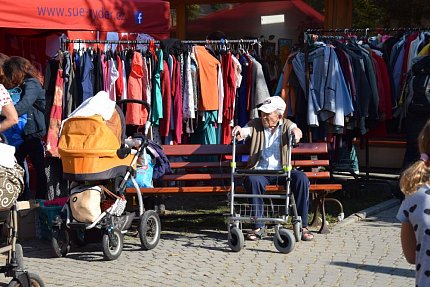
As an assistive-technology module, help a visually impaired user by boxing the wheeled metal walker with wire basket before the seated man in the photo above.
[228,135,302,253]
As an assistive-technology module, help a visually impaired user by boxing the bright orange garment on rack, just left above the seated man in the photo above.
[194,46,221,111]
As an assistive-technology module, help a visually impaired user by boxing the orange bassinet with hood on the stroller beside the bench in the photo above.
[58,113,133,181]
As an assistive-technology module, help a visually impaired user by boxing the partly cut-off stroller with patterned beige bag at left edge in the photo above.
[0,134,45,286]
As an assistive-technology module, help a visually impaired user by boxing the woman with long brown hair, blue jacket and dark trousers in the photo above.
[3,56,47,200]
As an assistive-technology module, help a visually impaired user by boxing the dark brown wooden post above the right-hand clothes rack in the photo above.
[324,0,352,29]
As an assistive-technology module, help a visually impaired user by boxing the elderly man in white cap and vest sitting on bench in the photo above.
[232,96,314,241]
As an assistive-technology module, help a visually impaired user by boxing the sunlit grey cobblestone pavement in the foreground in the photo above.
[0,202,415,287]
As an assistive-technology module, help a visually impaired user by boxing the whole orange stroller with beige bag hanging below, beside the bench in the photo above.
[51,98,161,260]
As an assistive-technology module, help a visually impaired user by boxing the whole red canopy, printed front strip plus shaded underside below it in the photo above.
[0,0,170,68]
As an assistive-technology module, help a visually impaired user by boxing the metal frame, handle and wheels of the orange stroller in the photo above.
[51,99,161,260]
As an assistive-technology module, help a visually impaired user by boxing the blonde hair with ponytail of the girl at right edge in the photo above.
[400,120,430,195]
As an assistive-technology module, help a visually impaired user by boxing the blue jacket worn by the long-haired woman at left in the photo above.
[15,78,46,138]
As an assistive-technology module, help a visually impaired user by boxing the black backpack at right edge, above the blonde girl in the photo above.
[408,56,430,115]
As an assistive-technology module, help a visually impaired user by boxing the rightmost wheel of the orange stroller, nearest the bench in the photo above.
[139,210,161,250]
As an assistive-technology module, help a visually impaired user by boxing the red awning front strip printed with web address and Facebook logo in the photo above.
[0,0,170,38]
